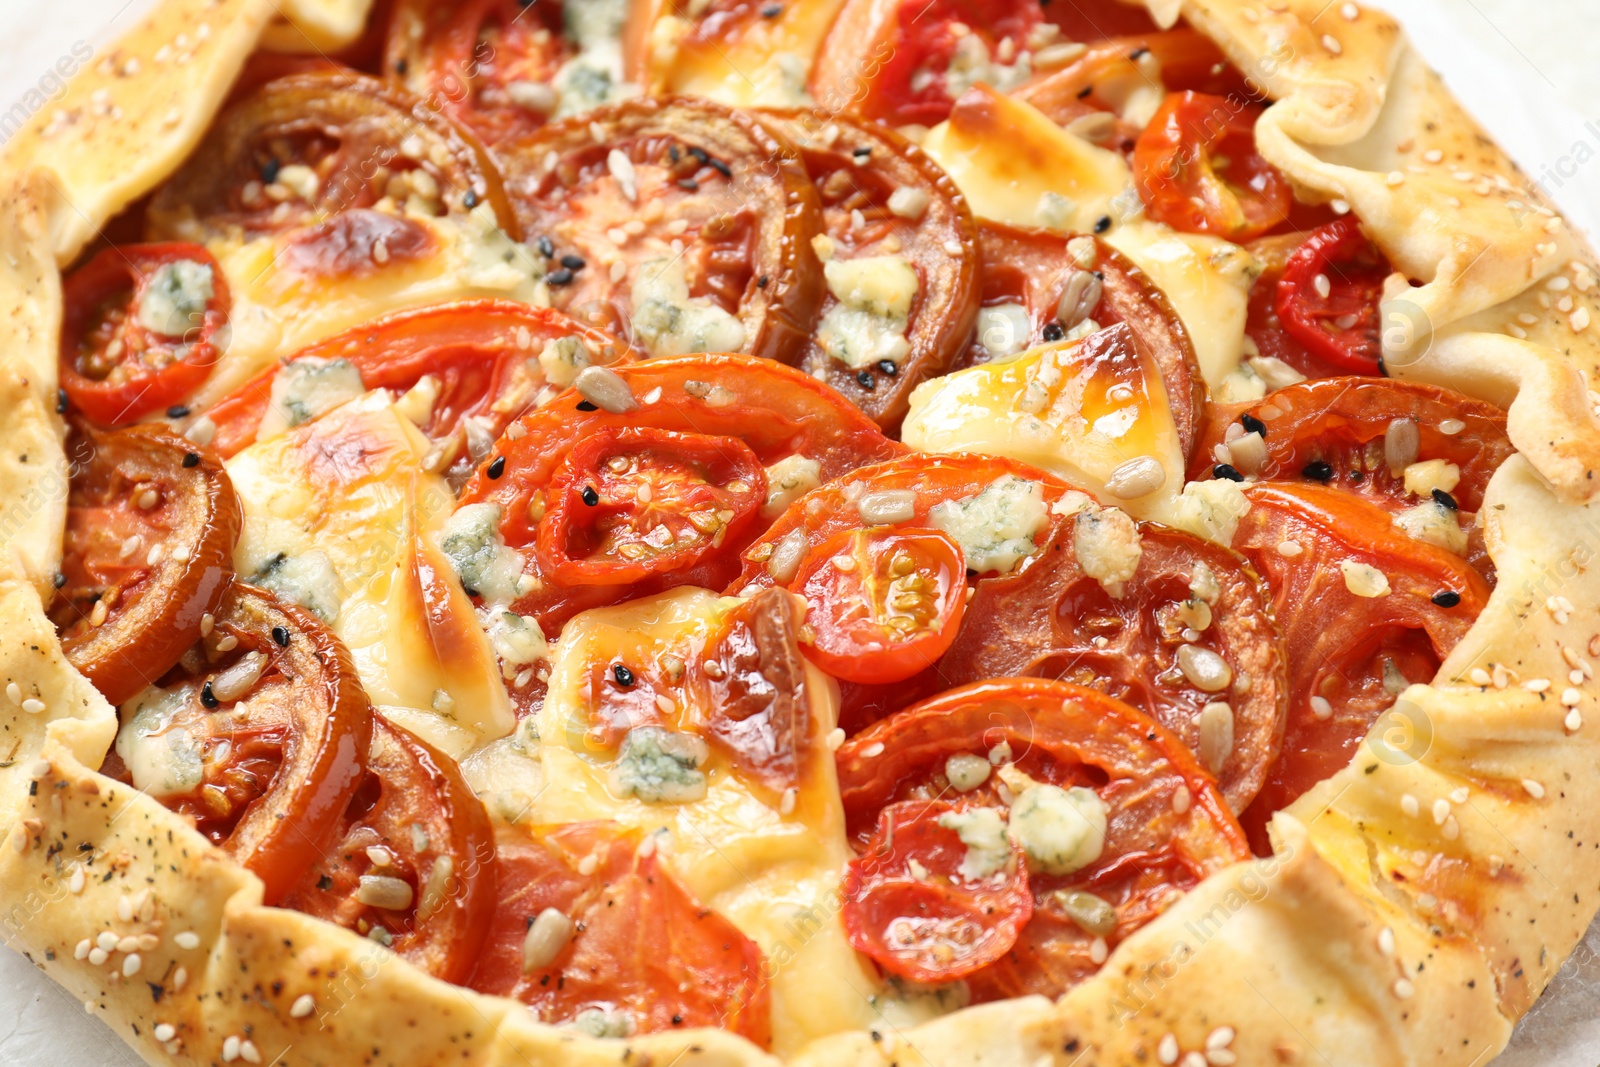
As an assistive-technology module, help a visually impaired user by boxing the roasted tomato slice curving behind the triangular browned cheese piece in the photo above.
[960,222,1206,456]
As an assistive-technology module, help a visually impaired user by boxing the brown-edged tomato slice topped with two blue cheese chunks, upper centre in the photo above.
[766,110,978,432]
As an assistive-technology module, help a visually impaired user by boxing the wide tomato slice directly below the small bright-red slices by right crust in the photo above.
[1189,378,1515,512]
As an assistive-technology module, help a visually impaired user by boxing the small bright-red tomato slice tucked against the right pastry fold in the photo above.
[1277,214,1390,374]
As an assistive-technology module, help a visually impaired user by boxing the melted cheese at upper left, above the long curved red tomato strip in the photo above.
[190,205,549,410]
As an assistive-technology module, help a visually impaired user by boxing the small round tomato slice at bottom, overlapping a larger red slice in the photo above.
[843,798,1034,982]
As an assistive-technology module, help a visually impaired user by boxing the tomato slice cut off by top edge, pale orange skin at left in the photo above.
[810,0,1061,126]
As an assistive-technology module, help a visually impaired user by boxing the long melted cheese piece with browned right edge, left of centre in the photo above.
[227,390,515,755]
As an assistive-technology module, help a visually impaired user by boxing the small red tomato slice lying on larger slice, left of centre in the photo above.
[534,427,766,585]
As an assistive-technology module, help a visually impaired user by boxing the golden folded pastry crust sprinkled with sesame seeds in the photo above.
[0,0,1600,1067]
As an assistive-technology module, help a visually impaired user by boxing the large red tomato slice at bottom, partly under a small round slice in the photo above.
[837,678,1248,1001]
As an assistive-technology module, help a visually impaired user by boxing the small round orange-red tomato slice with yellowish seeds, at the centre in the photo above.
[794,526,966,681]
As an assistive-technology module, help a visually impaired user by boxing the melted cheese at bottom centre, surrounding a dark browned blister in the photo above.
[512,589,882,1054]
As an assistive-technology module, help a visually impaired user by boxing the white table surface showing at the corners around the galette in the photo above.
[0,0,1600,1067]
